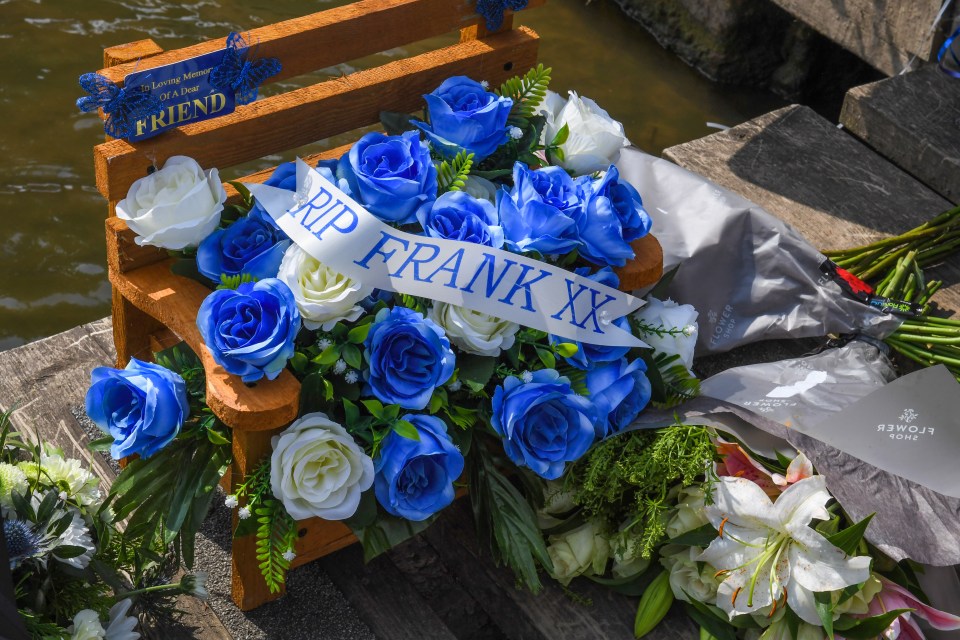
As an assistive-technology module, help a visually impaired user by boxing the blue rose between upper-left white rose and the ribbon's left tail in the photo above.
[197,209,290,282]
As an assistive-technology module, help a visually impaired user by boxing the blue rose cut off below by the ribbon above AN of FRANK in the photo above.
[417,191,503,249]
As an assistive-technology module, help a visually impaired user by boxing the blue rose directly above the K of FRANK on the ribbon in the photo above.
[497,162,583,255]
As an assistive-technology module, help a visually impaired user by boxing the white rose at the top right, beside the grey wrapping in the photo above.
[540,91,630,175]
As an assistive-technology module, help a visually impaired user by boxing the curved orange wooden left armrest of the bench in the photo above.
[107,252,300,431]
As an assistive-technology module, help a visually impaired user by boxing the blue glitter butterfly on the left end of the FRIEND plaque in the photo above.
[77,73,163,138]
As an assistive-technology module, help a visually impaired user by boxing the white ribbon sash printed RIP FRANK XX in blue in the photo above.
[251,159,647,347]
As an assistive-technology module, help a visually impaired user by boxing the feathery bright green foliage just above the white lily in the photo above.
[567,423,716,558]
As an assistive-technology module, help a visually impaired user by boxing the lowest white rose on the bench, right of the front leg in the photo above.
[270,413,373,520]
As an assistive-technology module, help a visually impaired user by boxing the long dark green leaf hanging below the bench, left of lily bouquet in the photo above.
[468,444,553,593]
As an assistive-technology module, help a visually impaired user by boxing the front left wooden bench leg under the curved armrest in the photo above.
[229,429,285,611]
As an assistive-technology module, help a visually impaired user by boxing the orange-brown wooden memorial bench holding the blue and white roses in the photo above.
[94,0,662,610]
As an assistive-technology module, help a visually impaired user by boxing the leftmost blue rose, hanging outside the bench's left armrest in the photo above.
[86,358,190,460]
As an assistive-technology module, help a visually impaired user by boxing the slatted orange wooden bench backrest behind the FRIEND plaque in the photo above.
[94,0,545,203]
